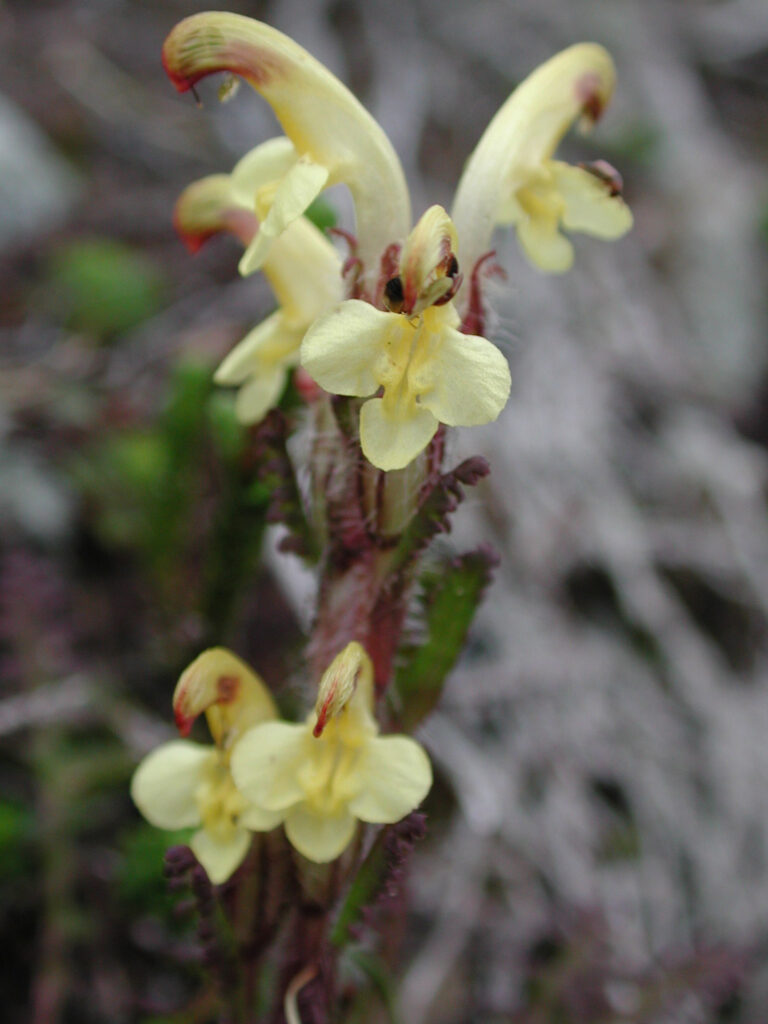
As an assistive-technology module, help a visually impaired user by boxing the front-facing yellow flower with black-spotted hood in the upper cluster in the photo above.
[301,206,510,470]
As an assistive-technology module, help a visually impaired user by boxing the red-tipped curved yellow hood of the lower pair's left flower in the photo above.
[173,647,276,749]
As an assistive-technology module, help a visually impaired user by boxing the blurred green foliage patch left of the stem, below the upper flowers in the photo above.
[69,360,271,645]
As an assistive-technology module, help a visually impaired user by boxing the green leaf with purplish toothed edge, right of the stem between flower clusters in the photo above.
[394,547,498,731]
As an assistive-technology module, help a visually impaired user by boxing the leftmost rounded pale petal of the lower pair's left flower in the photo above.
[131,739,211,829]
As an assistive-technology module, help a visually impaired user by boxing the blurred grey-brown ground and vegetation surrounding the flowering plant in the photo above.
[0,0,768,1024]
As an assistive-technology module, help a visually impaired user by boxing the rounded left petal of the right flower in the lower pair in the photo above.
[230,722,309,811]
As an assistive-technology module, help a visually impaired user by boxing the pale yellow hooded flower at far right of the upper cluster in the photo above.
[452,43,632,273]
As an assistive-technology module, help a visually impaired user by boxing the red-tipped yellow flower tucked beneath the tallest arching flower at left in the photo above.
[174,138,342,424]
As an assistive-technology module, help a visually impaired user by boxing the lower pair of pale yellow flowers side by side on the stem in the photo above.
[131,642,432,884]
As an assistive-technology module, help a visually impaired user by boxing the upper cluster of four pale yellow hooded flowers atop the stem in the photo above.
[163,12,632,470]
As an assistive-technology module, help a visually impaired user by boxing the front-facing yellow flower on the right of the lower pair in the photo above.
[231,642,432,863]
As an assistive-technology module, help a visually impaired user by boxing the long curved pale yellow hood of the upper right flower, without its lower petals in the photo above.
[452,43,615,299]
